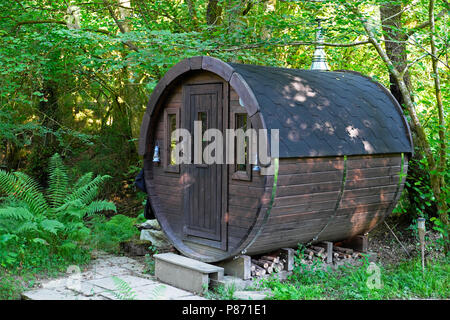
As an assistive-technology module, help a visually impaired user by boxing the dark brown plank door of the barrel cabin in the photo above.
[182,84,226,249]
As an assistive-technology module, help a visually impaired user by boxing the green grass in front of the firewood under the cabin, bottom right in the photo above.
[261,252,450,300]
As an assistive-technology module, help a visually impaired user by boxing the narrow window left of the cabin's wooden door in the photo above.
[164,108,180,173]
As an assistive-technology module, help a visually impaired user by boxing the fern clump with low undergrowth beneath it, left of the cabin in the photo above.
[0,154,116,267]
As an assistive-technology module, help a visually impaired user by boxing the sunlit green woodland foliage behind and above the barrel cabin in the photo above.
[0,0,450,230]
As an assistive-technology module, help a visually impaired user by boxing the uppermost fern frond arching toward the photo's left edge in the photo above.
[0,170,49,215]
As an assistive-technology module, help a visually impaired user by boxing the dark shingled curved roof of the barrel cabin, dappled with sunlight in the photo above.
[230,63,413,157]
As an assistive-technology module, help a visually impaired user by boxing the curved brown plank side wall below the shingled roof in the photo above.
[244,154,408,253]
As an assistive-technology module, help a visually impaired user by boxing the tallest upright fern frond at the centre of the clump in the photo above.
[48,153,69,208]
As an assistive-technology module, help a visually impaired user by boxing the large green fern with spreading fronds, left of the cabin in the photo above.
[0,154,116,251]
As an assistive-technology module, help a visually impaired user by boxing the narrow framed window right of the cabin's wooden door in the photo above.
[231,107,252,181]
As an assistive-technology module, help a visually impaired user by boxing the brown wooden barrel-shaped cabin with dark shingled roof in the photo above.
[139,56,413,262]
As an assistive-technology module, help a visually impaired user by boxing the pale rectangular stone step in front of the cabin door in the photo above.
[153,253,224,293]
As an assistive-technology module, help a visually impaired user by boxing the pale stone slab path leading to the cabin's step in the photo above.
[22,253,206,300]
